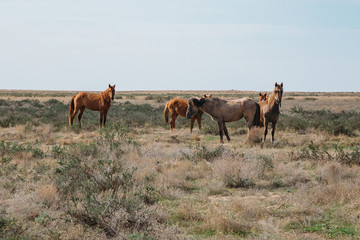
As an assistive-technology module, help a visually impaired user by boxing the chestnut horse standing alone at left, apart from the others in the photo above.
[69,84,115,128]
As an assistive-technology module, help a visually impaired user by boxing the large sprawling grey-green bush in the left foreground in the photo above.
[54,159,167,237]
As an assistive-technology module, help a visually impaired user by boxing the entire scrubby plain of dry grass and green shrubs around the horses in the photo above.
[0,91,360,239]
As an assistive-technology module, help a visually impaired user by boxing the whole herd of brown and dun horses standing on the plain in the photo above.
[69,83,283,142]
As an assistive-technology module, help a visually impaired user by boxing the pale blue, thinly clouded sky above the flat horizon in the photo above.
[0,0,360,91]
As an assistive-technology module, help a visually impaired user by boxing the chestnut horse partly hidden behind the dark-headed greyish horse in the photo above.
[164,95,212,133]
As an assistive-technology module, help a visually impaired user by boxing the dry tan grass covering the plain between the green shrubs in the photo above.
[0,91,360,239]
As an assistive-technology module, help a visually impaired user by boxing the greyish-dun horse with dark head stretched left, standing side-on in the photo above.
[186,97,260,143]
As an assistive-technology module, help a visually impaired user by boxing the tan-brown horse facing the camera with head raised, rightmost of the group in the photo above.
[259,82,283,143]
